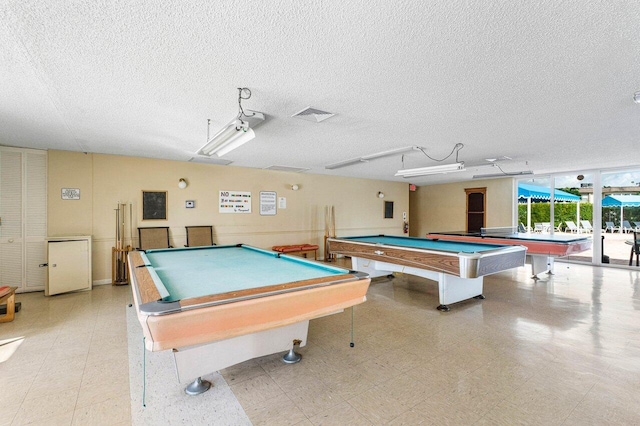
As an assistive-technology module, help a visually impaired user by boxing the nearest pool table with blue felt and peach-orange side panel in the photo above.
[129,244,370,393]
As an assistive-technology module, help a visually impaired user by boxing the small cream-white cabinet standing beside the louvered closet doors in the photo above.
[44,235,92,296]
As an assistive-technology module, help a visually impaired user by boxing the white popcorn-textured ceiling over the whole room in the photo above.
[0,0,640,185]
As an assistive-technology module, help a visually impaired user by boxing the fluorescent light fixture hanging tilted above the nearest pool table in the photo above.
[198,87,265,157]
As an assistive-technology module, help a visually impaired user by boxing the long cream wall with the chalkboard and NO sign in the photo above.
[47,150,409,283]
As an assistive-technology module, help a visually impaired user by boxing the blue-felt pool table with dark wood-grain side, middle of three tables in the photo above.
[327,235,526,311]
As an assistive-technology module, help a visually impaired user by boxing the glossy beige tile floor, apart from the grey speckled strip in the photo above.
[0,262,640,425]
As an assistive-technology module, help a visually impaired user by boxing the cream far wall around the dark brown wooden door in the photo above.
[410,178,516,237]
